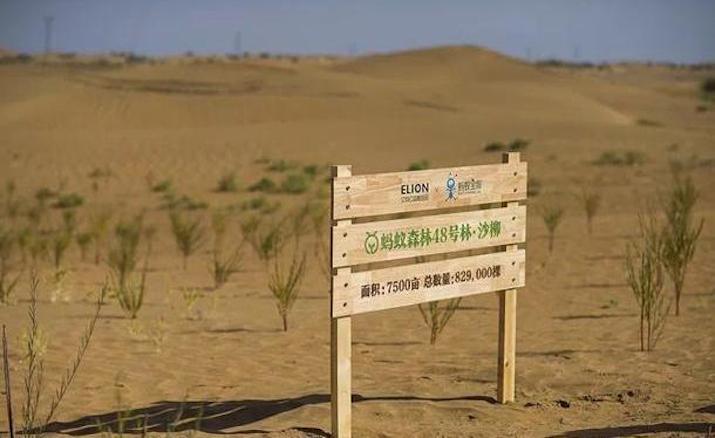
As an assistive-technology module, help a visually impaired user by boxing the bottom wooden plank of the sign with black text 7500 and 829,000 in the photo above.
[331,250,525,318]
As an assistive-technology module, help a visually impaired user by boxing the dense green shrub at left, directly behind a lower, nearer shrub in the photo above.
[107,216,143,288]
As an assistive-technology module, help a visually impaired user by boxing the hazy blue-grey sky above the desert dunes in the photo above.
[0,0,715,63]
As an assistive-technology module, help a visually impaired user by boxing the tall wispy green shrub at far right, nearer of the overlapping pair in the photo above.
[625,214,670,351]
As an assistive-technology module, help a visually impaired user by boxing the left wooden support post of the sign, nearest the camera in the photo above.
[330,166,352,438]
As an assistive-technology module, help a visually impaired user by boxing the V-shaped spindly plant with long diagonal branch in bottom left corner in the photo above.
[22,272,107,437]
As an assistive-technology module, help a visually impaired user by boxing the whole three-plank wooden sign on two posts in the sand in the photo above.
[331,153,527,437]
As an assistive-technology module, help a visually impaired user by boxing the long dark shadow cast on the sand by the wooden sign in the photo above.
[39,394,496,437]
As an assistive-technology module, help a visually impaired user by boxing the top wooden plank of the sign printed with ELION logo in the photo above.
[333,162,527,219]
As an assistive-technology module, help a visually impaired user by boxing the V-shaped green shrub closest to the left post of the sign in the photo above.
[268,247,306,331]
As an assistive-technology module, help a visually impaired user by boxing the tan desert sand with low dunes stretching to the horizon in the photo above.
[0,47,715,437]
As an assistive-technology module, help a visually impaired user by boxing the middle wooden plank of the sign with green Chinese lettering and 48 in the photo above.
[332,204,526,267]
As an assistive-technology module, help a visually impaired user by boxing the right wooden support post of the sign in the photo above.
[497,152,519,403]
